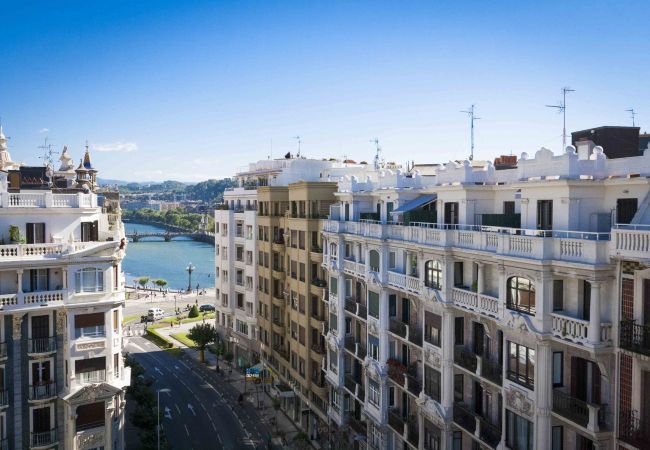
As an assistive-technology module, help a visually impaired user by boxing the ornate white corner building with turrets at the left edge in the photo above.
[0,129,130,450]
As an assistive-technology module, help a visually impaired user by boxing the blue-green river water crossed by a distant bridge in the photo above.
[123,223,214,289]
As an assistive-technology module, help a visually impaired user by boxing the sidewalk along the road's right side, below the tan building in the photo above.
[156,321,300,448]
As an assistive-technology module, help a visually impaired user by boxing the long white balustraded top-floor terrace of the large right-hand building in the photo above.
[323,220,612,264]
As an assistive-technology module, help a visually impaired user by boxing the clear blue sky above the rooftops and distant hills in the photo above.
[0,0,650,181]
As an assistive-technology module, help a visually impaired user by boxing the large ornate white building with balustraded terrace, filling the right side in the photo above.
[323,141,650,450]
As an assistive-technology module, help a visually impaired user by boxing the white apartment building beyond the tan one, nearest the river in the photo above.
[215,157,359,367]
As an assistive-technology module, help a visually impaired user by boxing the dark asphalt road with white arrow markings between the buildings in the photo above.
[126,337,273,450]
